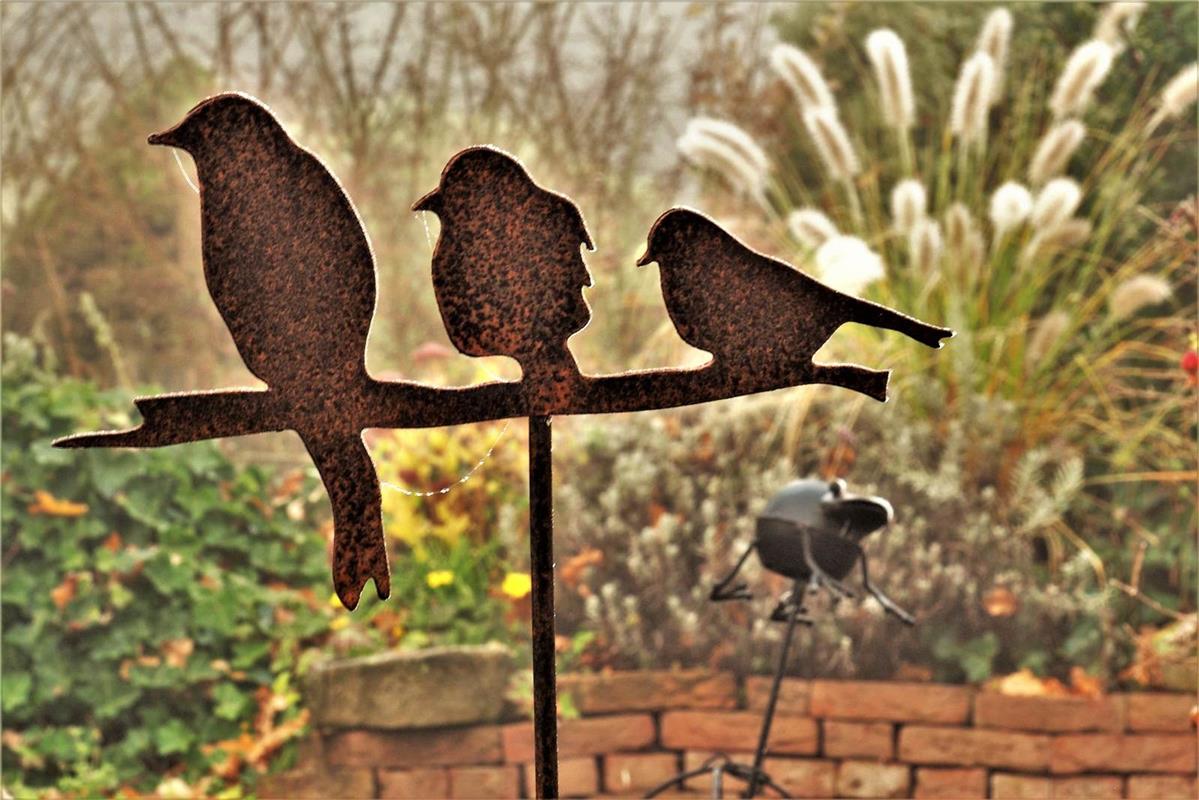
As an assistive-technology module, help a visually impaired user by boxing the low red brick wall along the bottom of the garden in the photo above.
[261,672,1197,800]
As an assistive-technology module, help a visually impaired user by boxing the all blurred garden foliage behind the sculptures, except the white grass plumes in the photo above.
[0,2,1199,798]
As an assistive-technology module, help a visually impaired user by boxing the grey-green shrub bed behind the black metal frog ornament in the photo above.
[556,384,1179,681]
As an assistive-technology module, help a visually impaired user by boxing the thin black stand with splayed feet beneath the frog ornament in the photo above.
[645,578,819,798]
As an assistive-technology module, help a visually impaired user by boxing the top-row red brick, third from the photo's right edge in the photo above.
[811,680,972,723]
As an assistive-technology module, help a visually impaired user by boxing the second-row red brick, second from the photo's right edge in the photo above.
[899,726,1049,770]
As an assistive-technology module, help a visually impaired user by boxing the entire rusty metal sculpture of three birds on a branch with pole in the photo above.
[55,94,952,798]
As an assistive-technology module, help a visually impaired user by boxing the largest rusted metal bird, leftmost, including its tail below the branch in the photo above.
[149,94,390,608]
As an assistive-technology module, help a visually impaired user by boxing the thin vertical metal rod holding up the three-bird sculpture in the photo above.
[529,416,558,800]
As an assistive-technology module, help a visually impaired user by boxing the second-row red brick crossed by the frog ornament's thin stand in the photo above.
[662,711,820,756]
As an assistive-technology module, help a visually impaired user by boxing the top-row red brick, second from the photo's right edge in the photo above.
[974,692,1123,733]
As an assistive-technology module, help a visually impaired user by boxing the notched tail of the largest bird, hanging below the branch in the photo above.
[300,431,391,610]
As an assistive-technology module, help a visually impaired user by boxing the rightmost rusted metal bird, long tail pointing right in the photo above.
[637,209,953,393]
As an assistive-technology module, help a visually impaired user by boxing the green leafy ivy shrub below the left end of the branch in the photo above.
[0,338,331,796]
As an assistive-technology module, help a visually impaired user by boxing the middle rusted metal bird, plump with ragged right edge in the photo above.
[412,148,594,391]
